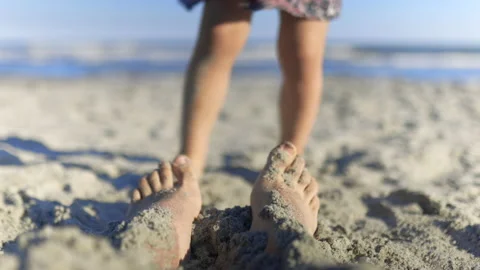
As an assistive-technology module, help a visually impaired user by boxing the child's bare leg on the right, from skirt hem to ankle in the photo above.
[278,12,328,154]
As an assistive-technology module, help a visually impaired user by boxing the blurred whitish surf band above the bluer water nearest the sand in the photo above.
[0,42,480,69]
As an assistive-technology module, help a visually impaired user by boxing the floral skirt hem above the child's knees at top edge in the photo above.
[179,0,342,20]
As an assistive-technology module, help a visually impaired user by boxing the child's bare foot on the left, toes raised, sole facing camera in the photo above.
[127,155,202,267]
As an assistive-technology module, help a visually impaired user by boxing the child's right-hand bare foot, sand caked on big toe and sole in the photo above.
[250,142,320,252]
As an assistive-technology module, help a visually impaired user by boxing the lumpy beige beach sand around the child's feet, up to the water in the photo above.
[0,76,480,269]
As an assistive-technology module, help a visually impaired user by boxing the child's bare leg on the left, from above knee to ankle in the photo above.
[181,0,252,176]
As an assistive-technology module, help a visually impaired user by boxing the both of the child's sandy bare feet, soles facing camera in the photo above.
[128,142,319,266]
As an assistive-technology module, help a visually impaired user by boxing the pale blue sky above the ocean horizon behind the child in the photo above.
[0,0,480,44]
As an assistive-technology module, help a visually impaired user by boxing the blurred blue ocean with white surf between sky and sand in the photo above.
[0,41,480,81]
